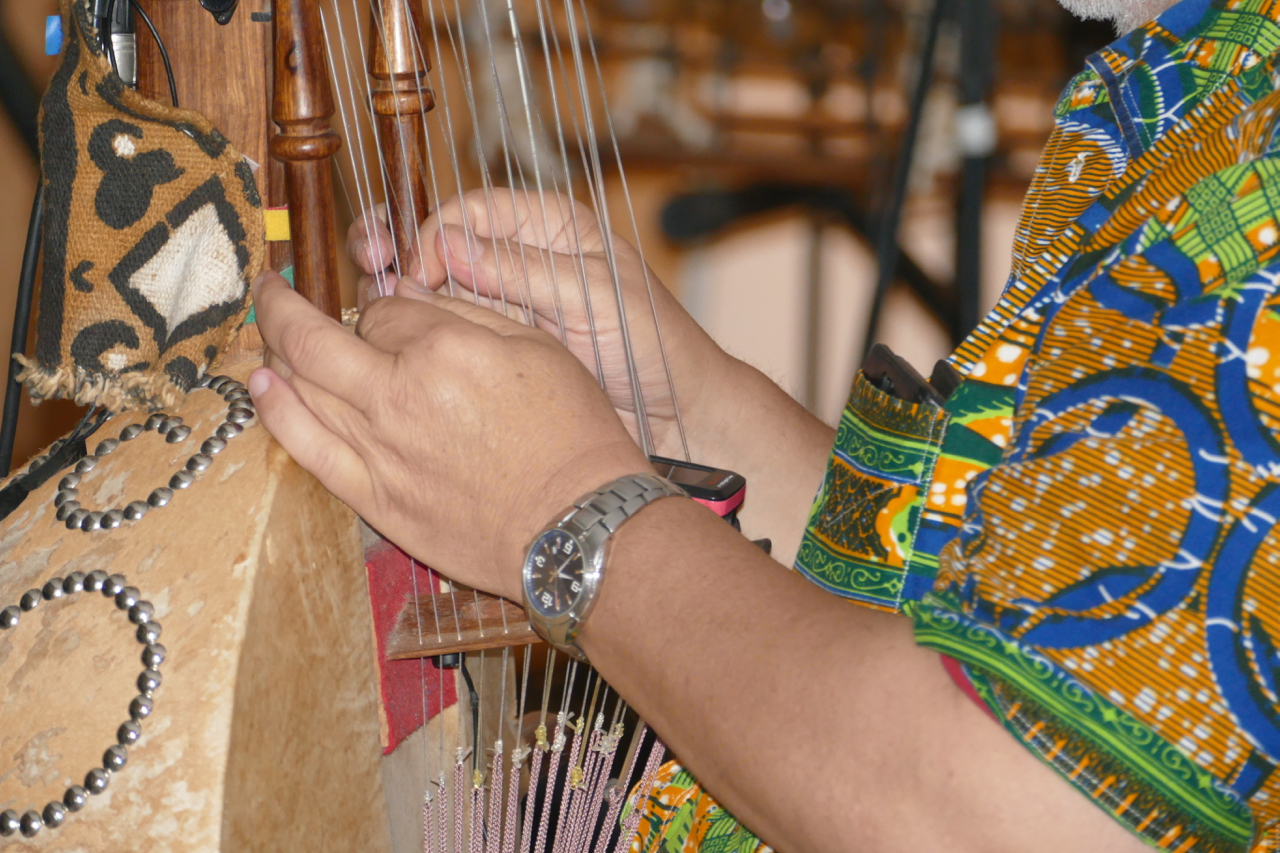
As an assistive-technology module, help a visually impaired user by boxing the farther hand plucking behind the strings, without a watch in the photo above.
[348,188,732,457]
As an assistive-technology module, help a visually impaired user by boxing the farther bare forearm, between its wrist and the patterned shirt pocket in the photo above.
[686,356,836,566]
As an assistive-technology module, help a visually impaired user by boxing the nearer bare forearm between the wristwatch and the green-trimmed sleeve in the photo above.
[581,501,1139,853]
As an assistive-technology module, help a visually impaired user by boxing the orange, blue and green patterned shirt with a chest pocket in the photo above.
[634,0,1280,853]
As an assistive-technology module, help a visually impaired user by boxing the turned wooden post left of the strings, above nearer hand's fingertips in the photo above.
[271,0,342,319]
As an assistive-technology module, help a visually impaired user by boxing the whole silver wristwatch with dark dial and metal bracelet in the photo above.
[524,474,685,661]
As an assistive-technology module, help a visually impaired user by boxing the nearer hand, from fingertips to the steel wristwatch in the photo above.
[248,267,652,601]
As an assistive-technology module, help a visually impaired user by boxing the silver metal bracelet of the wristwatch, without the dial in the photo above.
[524,474,687,661]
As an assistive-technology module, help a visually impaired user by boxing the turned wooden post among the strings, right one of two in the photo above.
[369,0,435,273]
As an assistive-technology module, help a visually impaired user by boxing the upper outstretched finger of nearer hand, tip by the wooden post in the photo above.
[253,272,385,409]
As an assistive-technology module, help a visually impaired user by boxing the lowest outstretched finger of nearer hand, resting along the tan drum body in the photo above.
[248,368,370,506]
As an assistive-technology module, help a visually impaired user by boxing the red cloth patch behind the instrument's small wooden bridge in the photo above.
[365,539,458,756]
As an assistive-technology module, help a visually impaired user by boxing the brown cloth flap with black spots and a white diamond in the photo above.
[19,0,266,411]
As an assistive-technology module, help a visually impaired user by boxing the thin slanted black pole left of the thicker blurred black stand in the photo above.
[863,0,951,356]
